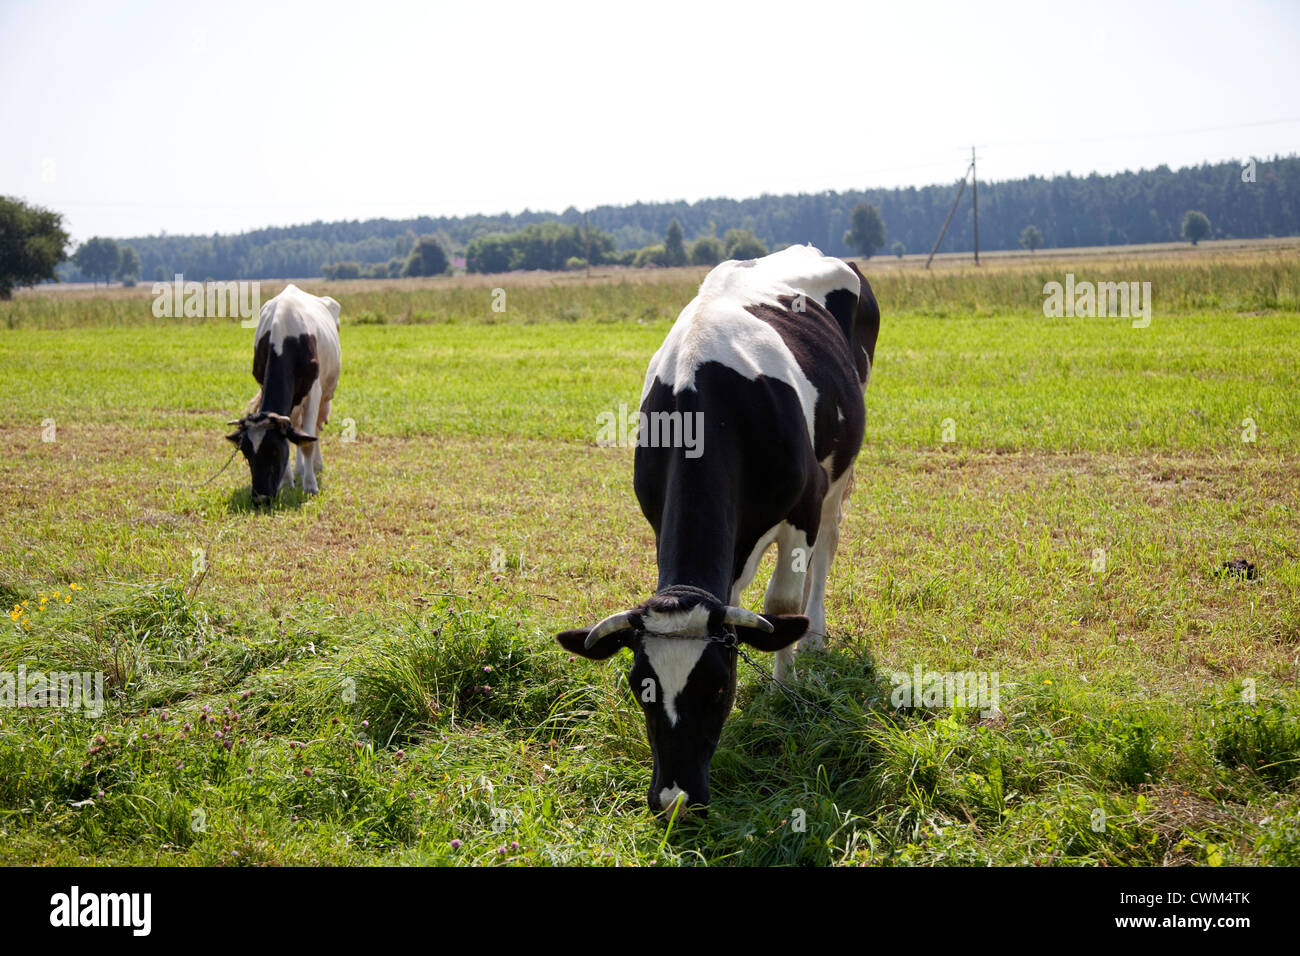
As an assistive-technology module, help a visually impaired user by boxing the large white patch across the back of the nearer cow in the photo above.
[641,246,859,440]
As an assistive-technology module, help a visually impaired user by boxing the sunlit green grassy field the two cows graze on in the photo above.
[0,243,1300,865]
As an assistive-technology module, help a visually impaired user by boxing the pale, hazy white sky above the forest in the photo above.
[0,0,1300,241]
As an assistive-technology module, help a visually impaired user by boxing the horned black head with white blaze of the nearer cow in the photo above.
[556,585,809,813]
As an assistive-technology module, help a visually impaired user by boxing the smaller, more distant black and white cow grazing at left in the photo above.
[226,284,342,505]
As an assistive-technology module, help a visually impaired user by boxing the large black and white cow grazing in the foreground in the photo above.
[556,246,880,810]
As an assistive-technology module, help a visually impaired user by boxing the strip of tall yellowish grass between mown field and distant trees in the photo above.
[0,251,1300,329]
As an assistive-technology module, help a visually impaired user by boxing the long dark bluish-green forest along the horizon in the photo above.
[60,156,1300,281]
